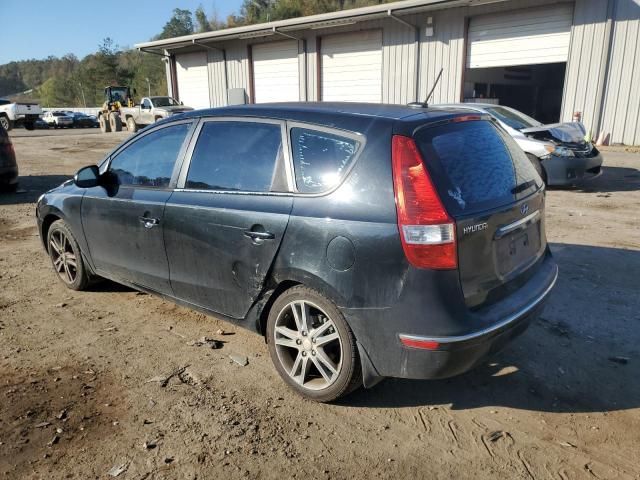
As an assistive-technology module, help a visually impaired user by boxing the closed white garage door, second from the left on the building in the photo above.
[251,40,300,103]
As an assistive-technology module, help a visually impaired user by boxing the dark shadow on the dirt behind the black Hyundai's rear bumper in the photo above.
[340,244,640,413]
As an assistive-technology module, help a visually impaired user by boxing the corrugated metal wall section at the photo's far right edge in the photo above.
[601,0,640,145]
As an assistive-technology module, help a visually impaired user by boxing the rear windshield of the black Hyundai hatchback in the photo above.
[415,120,542,216]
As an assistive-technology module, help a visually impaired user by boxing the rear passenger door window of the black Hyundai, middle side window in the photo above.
[185,122,286,192]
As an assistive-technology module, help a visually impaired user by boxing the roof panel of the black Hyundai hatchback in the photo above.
[181,102,482,124]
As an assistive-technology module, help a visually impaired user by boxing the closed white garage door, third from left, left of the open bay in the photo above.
[320,30,382,103]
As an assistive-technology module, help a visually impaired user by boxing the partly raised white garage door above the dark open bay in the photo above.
[467,3,573,68]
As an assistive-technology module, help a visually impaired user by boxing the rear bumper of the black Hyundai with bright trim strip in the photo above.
[342,254,558,386]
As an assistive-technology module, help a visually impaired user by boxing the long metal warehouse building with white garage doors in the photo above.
[136,0,640,145]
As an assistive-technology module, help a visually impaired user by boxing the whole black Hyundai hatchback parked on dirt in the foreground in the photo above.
[37,103,557,401]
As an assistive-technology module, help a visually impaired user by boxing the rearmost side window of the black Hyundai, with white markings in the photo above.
[291,128,360,193]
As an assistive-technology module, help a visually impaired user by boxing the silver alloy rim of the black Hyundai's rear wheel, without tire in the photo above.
[273,300,343,390]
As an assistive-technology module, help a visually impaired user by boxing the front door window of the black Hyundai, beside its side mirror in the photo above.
[109,123,191,188]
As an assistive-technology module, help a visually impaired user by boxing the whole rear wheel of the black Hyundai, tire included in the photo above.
[267,286,362,402]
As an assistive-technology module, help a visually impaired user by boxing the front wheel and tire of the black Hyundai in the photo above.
[47,220,91,290]
